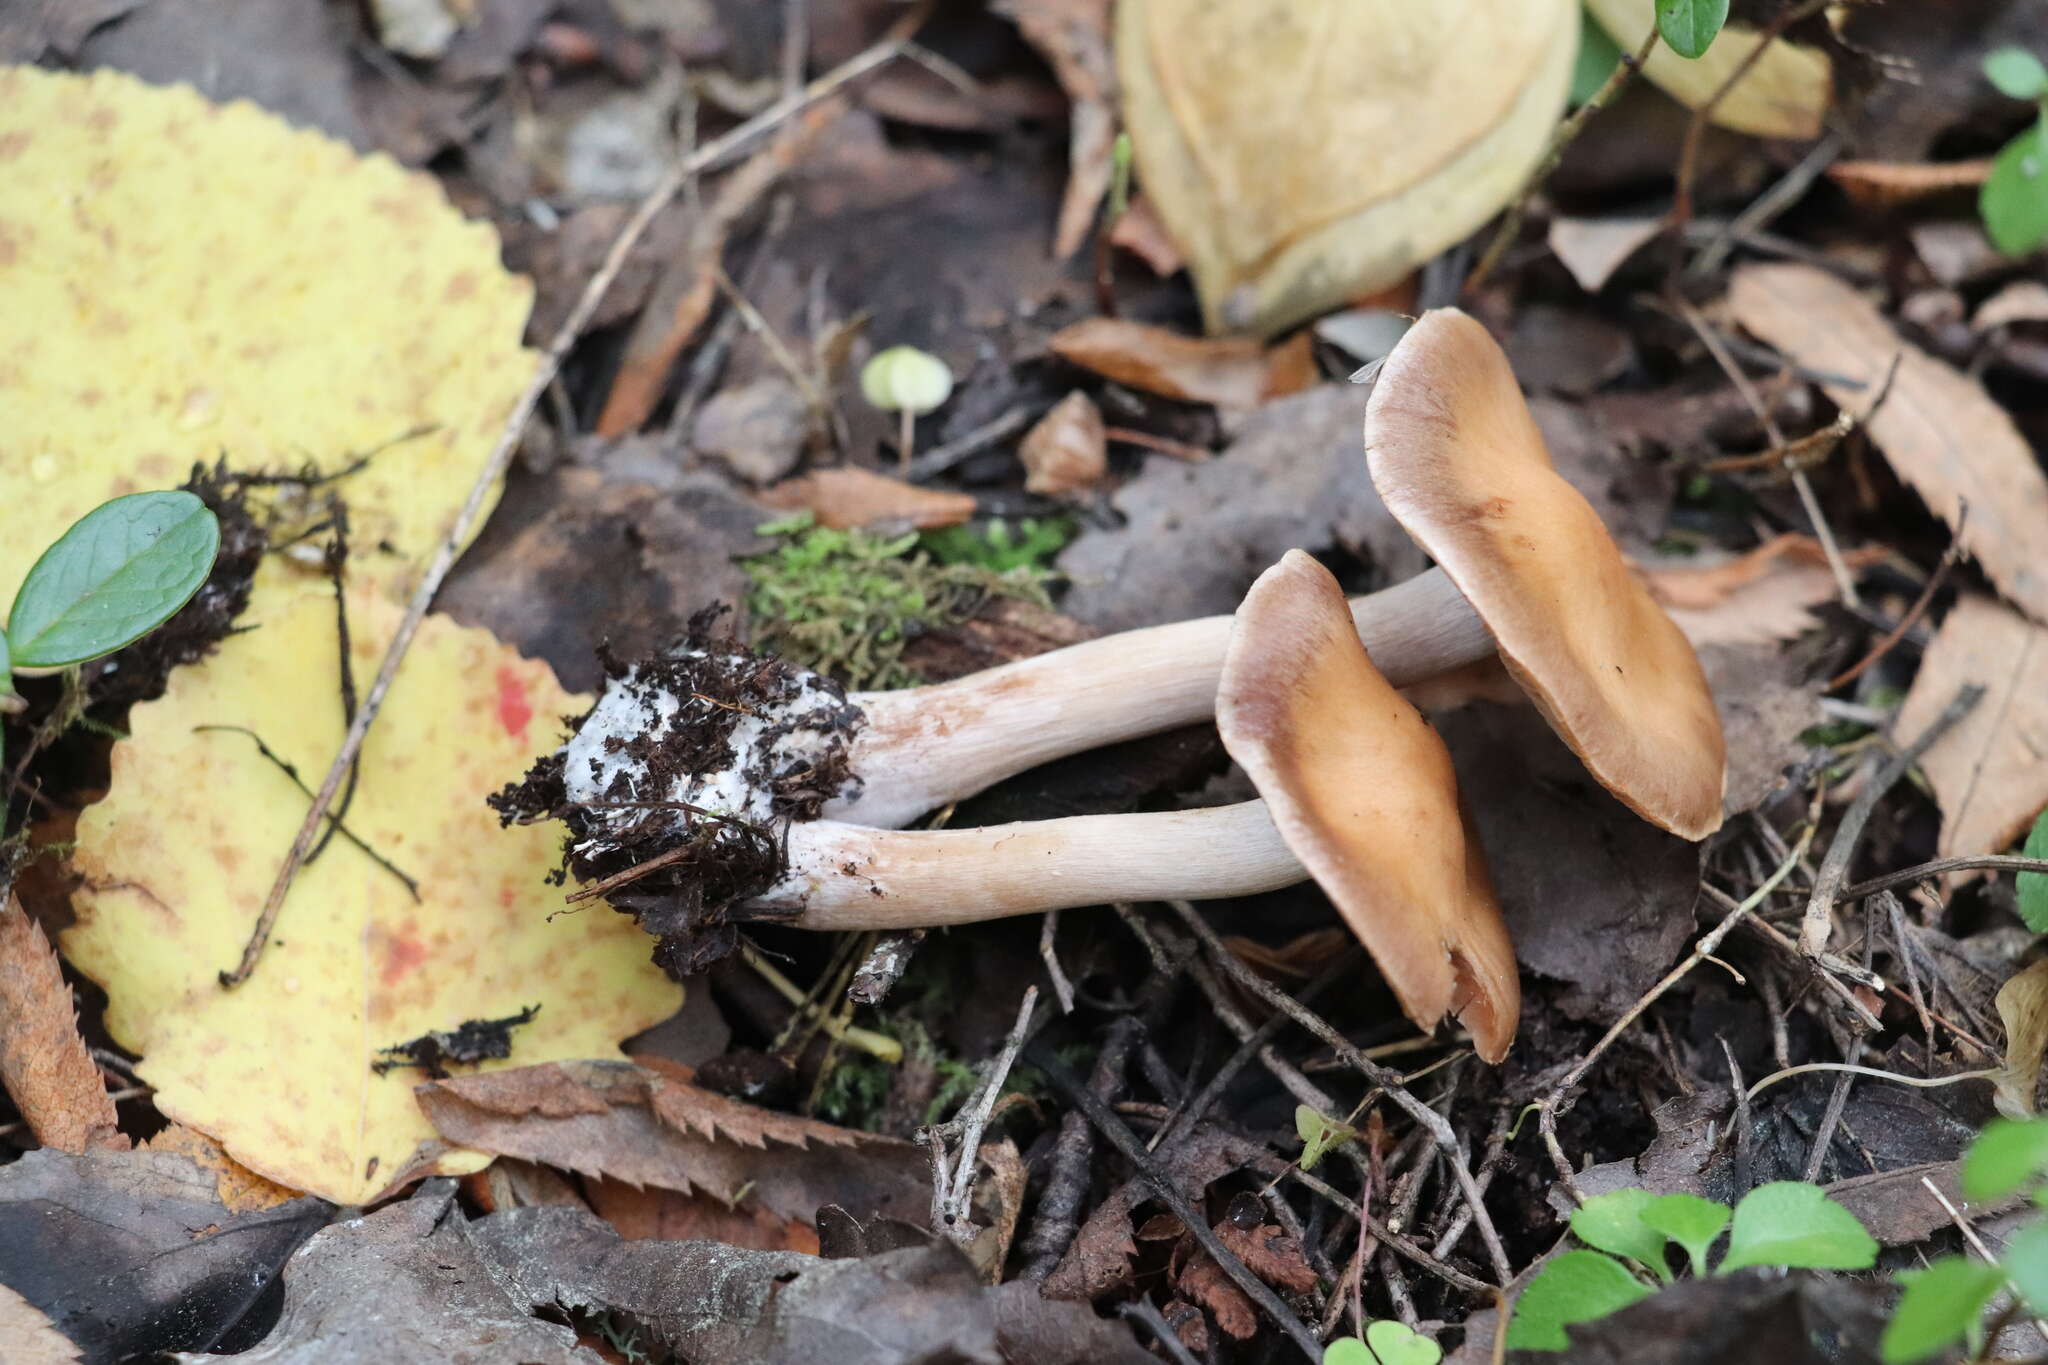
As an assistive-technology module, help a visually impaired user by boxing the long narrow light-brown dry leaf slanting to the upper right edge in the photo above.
[1729,264,2048,620]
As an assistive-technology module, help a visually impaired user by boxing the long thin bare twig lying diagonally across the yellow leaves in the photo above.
[221,34,924,988]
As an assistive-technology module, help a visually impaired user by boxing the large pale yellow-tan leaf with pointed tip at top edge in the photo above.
[1116,0,1579,336]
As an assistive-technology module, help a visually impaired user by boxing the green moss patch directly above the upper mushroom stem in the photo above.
[739,514,1065,688]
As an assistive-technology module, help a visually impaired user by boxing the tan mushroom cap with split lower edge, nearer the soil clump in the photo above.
[1217,551,1522,1062]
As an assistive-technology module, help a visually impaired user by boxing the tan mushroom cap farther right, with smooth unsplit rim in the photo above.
[1366,309,1726,839]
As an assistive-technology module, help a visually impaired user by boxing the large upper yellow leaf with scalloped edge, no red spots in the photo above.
[0,68,532,606]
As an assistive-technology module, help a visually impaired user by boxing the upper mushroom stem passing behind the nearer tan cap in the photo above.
[825,569,1493,826]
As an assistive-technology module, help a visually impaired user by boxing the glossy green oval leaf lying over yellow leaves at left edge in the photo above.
[8,491,221,669]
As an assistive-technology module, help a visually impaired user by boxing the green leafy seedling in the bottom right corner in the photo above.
[1878,1113,2048,1365]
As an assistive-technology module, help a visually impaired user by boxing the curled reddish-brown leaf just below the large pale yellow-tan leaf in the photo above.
[1047,317,1315,407]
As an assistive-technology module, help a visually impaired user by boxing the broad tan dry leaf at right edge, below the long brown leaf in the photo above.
[1896,593,2048,857]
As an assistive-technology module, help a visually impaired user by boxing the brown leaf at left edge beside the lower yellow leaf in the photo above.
[0,894,129,1152]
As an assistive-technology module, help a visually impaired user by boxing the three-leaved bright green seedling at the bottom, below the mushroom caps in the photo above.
[1507,1181,1878,1351]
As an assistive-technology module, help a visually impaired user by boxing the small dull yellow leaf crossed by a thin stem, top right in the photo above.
[1585,0,1833,137]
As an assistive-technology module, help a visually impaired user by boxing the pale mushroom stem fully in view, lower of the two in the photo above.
[754,800,1309,929]
